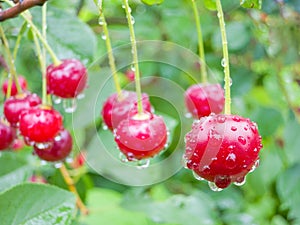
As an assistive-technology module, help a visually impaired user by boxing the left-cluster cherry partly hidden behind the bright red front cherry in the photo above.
[4,93,42,127]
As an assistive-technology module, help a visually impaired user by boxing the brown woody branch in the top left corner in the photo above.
[0,0,47,22]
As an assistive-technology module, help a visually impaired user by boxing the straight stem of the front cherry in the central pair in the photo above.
[123,0,143,115]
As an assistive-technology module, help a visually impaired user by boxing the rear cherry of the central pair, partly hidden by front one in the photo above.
[102,90,151,130]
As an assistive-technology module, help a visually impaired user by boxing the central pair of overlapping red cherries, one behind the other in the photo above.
[101,90,168,164]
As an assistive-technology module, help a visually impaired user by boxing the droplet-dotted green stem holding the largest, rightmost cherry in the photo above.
[216,0,231,115]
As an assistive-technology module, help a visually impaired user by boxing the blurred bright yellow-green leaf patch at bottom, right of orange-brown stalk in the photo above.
[79,188,149,225]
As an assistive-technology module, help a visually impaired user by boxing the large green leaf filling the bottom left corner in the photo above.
[0,184,75,225]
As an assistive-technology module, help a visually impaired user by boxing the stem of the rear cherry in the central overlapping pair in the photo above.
[94,0,122,99]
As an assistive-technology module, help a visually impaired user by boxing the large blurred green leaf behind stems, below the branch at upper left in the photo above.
[32,7,96,64]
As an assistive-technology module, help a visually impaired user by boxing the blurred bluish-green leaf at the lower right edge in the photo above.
[276,164,300,224]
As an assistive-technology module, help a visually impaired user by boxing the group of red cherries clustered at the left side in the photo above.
[0,59,87,162]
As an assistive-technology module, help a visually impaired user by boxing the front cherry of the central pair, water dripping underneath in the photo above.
[115,113,168,161]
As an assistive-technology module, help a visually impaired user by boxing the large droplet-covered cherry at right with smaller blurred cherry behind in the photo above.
[183,84,262,191]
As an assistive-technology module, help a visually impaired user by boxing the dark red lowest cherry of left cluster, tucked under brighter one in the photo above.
[34,129,73,162]
